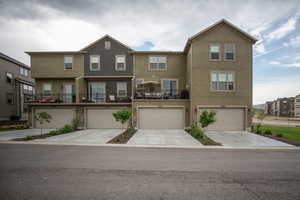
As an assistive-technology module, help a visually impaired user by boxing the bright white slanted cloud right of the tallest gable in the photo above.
[267,17,297,41]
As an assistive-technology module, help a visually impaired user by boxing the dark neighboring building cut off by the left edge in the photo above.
[0,52,34,120]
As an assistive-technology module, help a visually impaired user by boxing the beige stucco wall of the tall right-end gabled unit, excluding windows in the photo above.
[188,24,253,127]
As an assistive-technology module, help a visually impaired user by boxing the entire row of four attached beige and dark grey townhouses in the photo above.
[28,20,256,130]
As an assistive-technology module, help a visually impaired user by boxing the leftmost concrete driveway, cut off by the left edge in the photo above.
[0,129,53,141]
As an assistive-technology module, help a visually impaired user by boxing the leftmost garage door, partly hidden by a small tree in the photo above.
[35,108,76,128]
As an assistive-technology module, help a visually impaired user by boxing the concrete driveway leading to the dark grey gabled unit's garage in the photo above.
[34,129,122,144]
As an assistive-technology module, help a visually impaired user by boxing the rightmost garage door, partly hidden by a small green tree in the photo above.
[198,109,245,131]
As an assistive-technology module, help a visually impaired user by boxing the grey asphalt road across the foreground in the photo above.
[0,144,300,200]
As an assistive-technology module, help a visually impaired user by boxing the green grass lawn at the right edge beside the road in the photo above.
[261,125,300,141]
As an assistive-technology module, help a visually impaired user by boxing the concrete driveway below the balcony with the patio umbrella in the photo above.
[127,129,202,146]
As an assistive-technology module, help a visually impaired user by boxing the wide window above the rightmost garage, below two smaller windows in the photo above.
[211,72,234,91]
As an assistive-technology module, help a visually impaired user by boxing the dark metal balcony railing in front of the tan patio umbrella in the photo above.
[134,88,189,99]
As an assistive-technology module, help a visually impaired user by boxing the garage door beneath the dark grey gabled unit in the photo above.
[87,109,122,128]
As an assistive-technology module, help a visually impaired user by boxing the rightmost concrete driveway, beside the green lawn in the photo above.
[205,131,292,147]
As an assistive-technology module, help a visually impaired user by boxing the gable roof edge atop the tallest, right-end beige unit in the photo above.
[183,19,257,52]
